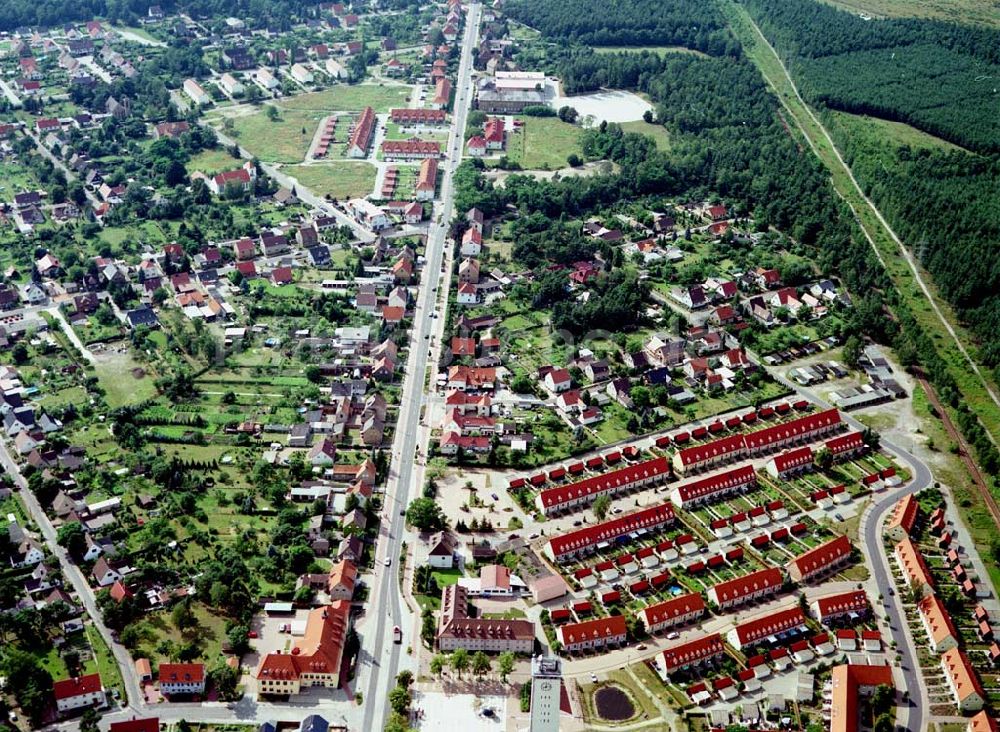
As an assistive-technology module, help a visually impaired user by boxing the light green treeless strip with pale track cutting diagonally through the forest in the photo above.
[720,0,1000,443]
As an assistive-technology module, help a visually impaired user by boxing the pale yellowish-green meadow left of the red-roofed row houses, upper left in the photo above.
[210,108,325,163]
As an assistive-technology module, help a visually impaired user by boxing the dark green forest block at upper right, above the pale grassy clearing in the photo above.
[746,0,1000,152]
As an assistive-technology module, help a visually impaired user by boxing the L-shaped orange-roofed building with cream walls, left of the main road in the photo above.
[256,600,351,697]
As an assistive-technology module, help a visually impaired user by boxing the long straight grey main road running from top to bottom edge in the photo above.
[358,3,482,730]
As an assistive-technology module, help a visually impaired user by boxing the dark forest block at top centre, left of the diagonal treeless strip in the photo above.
[504,0,739,56]
